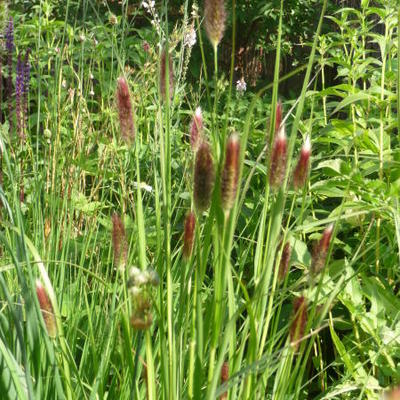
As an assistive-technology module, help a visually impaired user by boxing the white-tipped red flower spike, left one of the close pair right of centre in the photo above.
[269,125,287,188]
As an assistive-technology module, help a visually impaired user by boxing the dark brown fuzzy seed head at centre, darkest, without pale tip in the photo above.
[193,142,215,213]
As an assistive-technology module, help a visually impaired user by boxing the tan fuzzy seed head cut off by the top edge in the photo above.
[204,0,226,48]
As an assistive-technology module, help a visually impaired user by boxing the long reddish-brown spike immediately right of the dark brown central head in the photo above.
[221,133,240,212]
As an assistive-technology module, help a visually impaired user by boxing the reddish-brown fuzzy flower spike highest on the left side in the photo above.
[117,77,135,144]
